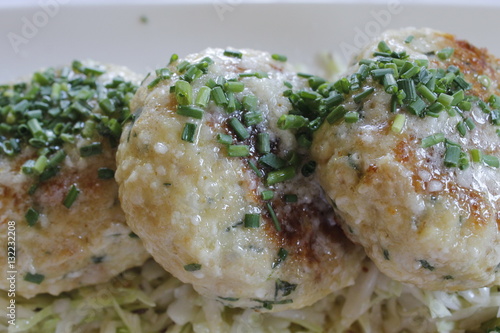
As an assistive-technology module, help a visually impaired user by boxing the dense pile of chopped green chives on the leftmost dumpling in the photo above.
[0,61,137,188]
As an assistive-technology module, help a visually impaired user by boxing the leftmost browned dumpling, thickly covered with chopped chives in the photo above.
[0,62,149,297]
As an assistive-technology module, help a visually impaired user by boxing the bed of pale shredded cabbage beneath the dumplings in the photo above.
[0,260,500,333]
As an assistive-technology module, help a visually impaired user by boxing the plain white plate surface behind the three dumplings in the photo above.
[0,0,500,83]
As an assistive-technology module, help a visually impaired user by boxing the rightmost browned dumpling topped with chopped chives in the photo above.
[312,29,500,291]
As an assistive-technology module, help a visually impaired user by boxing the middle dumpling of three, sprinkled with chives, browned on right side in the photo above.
[117,49,364,311]
